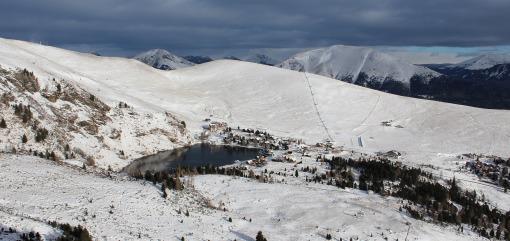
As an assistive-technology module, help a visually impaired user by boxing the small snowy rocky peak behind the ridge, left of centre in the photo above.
[134,49,195,70]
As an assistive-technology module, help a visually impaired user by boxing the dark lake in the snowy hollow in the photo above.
[124,144,260,174]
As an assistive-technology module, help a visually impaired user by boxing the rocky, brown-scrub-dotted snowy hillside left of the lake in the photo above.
[0,41,192,169]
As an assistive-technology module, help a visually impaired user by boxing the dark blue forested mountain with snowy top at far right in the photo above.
[420,54,510,110]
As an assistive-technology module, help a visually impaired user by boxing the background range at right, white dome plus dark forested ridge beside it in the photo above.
[278,45,510,109]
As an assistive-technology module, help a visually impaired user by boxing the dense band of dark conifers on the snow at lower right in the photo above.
[320,157,510,240]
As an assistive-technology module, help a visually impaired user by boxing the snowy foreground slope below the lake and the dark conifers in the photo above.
[0,155,483,241]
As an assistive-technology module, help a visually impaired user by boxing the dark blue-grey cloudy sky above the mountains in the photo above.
[0,0,510,63]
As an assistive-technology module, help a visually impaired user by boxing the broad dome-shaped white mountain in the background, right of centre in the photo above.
[278,45,438,84]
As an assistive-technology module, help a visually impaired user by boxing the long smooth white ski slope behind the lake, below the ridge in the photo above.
[0,39,510,162]
